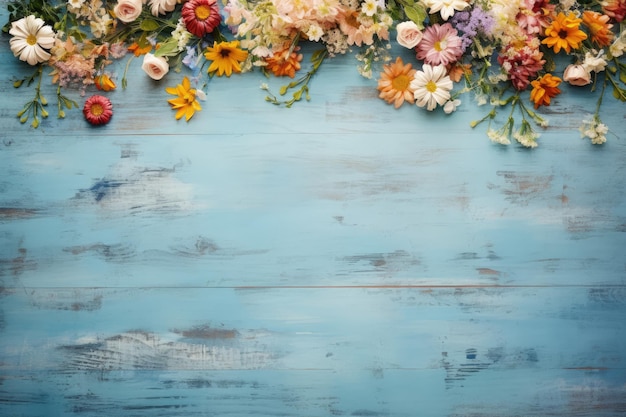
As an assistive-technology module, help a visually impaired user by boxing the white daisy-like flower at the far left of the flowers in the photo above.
[9,15,55,65]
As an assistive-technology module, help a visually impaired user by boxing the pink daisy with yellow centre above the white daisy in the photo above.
[416,23,463,66]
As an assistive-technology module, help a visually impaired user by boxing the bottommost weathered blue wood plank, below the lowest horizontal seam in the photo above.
[0,287,626,416]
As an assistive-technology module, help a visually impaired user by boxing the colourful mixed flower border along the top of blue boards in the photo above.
[3,0,626,147]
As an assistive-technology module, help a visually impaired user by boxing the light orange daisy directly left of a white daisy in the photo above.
[378,57,417,109]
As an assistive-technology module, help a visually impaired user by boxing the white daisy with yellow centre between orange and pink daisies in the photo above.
[411,64,453,111]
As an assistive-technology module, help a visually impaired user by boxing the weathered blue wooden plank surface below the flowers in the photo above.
[0,1,626,417]
